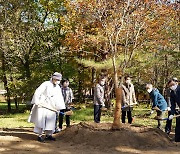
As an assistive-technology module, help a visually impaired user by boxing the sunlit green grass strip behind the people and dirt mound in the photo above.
[0,103,175,128]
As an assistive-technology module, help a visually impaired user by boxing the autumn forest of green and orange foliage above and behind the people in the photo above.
[0,0,180,112]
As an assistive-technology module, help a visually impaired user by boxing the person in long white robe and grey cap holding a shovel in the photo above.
[28,72,65,142]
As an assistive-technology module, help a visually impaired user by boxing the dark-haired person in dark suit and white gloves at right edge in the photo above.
[168,79,180,142]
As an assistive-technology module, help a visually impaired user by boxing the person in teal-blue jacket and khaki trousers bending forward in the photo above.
[146,84,167,129]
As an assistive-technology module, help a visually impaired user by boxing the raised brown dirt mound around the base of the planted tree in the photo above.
[57,123,177,153]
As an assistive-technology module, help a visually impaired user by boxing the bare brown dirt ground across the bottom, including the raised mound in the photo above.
[0,123,180,154]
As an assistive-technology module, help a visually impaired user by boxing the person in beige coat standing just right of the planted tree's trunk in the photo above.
[121,76,137,124]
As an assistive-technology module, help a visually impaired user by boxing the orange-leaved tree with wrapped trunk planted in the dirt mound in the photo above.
[63,0,179,129]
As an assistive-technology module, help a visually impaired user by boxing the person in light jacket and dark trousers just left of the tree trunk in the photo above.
[94,77,106,123]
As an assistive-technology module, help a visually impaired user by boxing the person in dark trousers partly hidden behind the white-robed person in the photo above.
[59,79,74,130]
